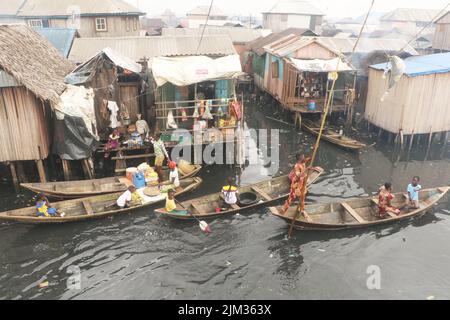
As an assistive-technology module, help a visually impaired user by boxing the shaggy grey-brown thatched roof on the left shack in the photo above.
[0,25,74,102]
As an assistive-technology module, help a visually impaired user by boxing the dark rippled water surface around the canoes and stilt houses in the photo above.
[0,106,450,299]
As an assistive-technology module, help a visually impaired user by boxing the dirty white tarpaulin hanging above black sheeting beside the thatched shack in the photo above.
[55,84,99,140]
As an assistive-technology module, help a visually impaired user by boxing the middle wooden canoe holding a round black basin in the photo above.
[155,168,324,220]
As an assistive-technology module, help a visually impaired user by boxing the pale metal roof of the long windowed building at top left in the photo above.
[18,0,144,17]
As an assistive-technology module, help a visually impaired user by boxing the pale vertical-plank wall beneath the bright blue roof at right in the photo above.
[365,69,450,134]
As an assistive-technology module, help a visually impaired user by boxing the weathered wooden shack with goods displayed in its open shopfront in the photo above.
[264,35,356,124]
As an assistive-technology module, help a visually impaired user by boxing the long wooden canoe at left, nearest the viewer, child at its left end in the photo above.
[0,177,202,224]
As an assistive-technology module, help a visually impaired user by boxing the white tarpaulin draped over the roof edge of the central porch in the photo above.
[152,55,242,87]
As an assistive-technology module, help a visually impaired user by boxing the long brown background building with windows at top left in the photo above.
[17,0,144,37]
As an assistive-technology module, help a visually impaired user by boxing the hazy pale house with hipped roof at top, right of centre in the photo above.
[263,1,325,33]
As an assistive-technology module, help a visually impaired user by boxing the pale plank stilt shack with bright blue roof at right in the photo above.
[364,53,450,143]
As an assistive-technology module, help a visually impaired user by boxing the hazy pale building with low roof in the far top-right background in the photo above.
[380,8,439,33]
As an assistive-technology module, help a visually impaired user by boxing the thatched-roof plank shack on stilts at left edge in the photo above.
[0,25,74,183]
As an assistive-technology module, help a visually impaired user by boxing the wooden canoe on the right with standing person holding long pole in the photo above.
[270,187,450,230]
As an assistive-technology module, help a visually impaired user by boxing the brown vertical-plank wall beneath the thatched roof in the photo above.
[0,87,51,162]
